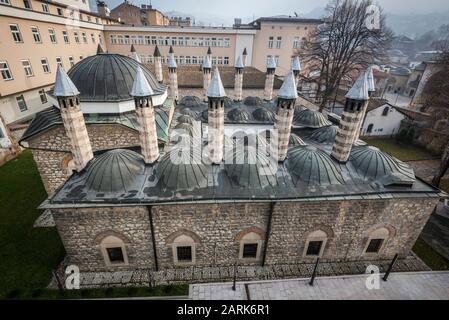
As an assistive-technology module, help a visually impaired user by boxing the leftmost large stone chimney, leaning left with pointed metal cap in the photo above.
[54,66,94,172]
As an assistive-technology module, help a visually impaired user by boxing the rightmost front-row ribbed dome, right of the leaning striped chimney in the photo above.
[349,146,415,186]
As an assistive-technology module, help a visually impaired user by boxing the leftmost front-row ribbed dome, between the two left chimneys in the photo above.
[86,149,145,193]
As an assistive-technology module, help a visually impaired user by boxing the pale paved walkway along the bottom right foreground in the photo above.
[189,272,449,300]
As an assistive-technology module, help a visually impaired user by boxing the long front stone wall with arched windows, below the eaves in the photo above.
[52,198,438,271]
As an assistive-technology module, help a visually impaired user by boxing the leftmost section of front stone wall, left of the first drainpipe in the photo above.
[52,207,154,271]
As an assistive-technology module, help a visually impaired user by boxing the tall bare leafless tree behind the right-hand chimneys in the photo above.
[305,0,392,111]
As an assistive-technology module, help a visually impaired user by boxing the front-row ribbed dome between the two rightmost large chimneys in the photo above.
[287,146,344,185]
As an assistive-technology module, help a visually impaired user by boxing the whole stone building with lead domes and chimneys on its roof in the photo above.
[21,54,441,284]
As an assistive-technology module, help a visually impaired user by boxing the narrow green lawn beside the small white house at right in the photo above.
[363,138,437,161]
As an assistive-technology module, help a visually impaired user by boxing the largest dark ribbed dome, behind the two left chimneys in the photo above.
[68,53,165,102]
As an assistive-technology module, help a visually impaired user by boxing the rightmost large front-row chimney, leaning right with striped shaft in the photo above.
[332,72,369,163]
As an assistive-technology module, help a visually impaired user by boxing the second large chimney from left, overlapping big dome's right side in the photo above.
[131,65,159,163]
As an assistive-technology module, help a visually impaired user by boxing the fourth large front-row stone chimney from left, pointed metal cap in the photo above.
[274,71,298,161]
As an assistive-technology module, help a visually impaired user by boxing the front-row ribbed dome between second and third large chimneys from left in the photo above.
[156,147,208,190]
